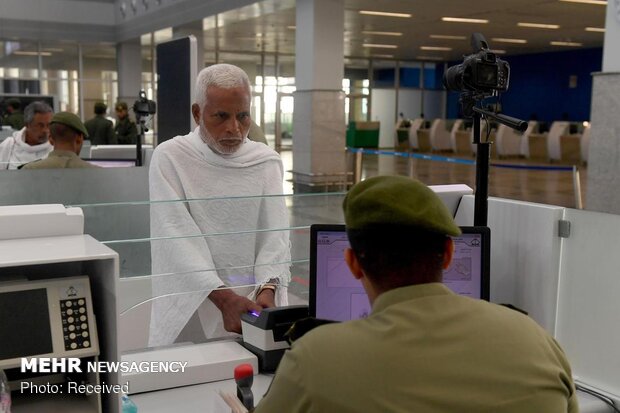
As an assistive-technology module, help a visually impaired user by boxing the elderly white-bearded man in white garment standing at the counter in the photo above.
[149,64,290,346]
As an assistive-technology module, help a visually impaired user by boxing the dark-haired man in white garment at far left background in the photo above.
[0,101,52,169]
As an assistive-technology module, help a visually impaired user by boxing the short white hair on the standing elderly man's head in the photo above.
[195,63,251,109]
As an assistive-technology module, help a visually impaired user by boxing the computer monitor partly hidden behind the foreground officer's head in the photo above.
[309,224,491,321]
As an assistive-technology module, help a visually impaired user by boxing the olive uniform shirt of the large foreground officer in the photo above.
[254,283,578,413]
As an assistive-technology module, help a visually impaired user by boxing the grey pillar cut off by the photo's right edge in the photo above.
[585,0,620,214]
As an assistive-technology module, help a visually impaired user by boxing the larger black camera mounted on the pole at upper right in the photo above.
[443,33,510,96]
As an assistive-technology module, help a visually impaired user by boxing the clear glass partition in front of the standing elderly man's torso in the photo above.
[73,192,345,350]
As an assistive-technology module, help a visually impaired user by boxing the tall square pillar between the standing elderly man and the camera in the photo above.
[293,0,347,191]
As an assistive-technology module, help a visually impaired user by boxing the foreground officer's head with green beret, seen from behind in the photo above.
[343,176,461,295]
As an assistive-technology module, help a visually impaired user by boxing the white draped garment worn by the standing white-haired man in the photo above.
[149,128,290,346]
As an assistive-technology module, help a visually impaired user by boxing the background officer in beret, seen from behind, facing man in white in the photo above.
[21,112,96,169]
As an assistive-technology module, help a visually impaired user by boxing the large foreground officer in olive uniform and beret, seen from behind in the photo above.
[255,176,578,413]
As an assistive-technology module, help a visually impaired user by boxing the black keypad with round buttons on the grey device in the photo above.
[60,298,90,350]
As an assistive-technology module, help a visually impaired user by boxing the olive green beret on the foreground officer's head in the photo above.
[342,176,461,236]
